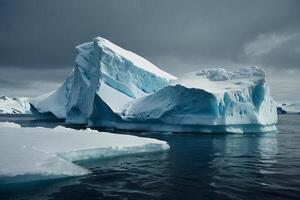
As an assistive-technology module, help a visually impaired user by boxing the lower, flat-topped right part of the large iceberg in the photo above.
[119,67,277,132]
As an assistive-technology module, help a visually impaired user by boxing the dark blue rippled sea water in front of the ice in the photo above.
[0,115,300,200]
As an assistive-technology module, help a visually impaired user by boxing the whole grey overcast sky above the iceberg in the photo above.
[0,0,300,102]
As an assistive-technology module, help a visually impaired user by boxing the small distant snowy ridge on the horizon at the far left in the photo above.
[0,96,31,114]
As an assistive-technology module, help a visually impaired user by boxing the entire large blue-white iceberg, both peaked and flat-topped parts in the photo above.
[30,37,277,133]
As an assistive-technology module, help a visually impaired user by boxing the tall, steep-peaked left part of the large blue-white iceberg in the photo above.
[30,37,175,124]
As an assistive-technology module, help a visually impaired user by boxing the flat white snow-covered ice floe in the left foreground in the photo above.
[0,122,169,183]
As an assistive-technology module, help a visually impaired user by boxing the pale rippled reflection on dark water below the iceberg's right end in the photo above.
[210,133,278,199]
